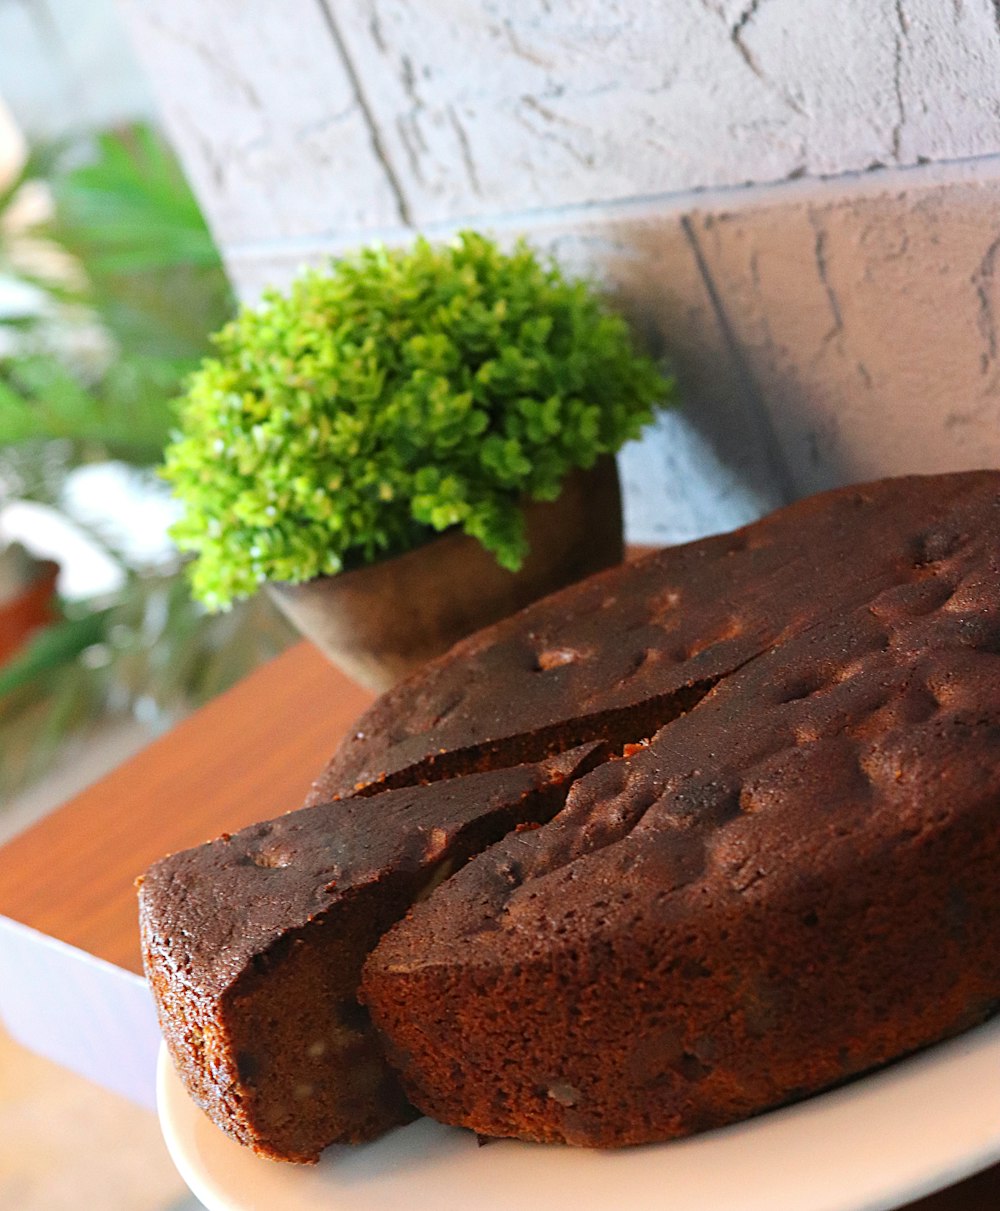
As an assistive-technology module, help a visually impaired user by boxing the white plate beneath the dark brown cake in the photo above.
[157,1018,1000,1211]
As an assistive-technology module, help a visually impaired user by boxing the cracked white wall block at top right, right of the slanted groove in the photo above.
[328,0,1000,223]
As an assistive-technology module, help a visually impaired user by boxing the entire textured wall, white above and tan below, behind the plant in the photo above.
[113,0,1000,541]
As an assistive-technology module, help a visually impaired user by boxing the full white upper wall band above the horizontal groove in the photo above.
[121,0,1000,233]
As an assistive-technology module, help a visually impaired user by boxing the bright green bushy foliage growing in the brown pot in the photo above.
[163,231,673,608]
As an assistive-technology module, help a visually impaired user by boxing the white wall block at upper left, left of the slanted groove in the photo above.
[116,0,401,247]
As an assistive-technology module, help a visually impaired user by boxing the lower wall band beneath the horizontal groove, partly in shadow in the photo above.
[208,168,1000,543]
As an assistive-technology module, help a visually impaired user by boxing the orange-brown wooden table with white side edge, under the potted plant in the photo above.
[0,643,1000,1211]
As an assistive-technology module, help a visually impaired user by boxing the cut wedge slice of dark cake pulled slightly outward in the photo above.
[139,744,603,1161]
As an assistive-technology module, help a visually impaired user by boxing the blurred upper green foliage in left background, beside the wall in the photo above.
[0,126,232,467]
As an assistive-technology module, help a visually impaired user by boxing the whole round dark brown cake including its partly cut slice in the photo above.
[142,471,1000,1160]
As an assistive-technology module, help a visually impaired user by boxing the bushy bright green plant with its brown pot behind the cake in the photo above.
[163,231,672,688]
